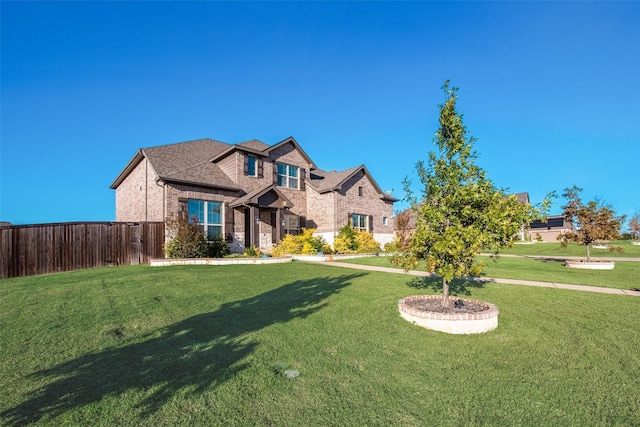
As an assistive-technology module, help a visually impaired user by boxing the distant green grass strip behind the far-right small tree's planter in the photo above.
[502,240,640,258]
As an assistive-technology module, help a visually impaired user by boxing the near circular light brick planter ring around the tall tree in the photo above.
[398,295,498,334]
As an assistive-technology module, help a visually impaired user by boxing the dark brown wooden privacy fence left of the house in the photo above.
[0,222,164,278]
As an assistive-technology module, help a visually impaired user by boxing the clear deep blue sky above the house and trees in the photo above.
[0,1,640,229]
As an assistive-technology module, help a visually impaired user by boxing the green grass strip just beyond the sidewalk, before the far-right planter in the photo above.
[342,257,640,289]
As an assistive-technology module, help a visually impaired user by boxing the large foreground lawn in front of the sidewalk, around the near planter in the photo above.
[0,263,640,426]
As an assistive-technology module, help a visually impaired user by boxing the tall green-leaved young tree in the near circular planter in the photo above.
[393,81,548,306]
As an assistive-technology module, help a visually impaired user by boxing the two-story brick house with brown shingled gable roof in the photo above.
[111,137,397,252]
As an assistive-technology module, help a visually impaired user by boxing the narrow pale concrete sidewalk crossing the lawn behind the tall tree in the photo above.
[322,261,640,297]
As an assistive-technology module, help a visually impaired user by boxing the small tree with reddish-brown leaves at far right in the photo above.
[558,185,625,261]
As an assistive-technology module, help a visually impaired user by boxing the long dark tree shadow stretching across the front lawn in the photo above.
[0,273,364,426]
